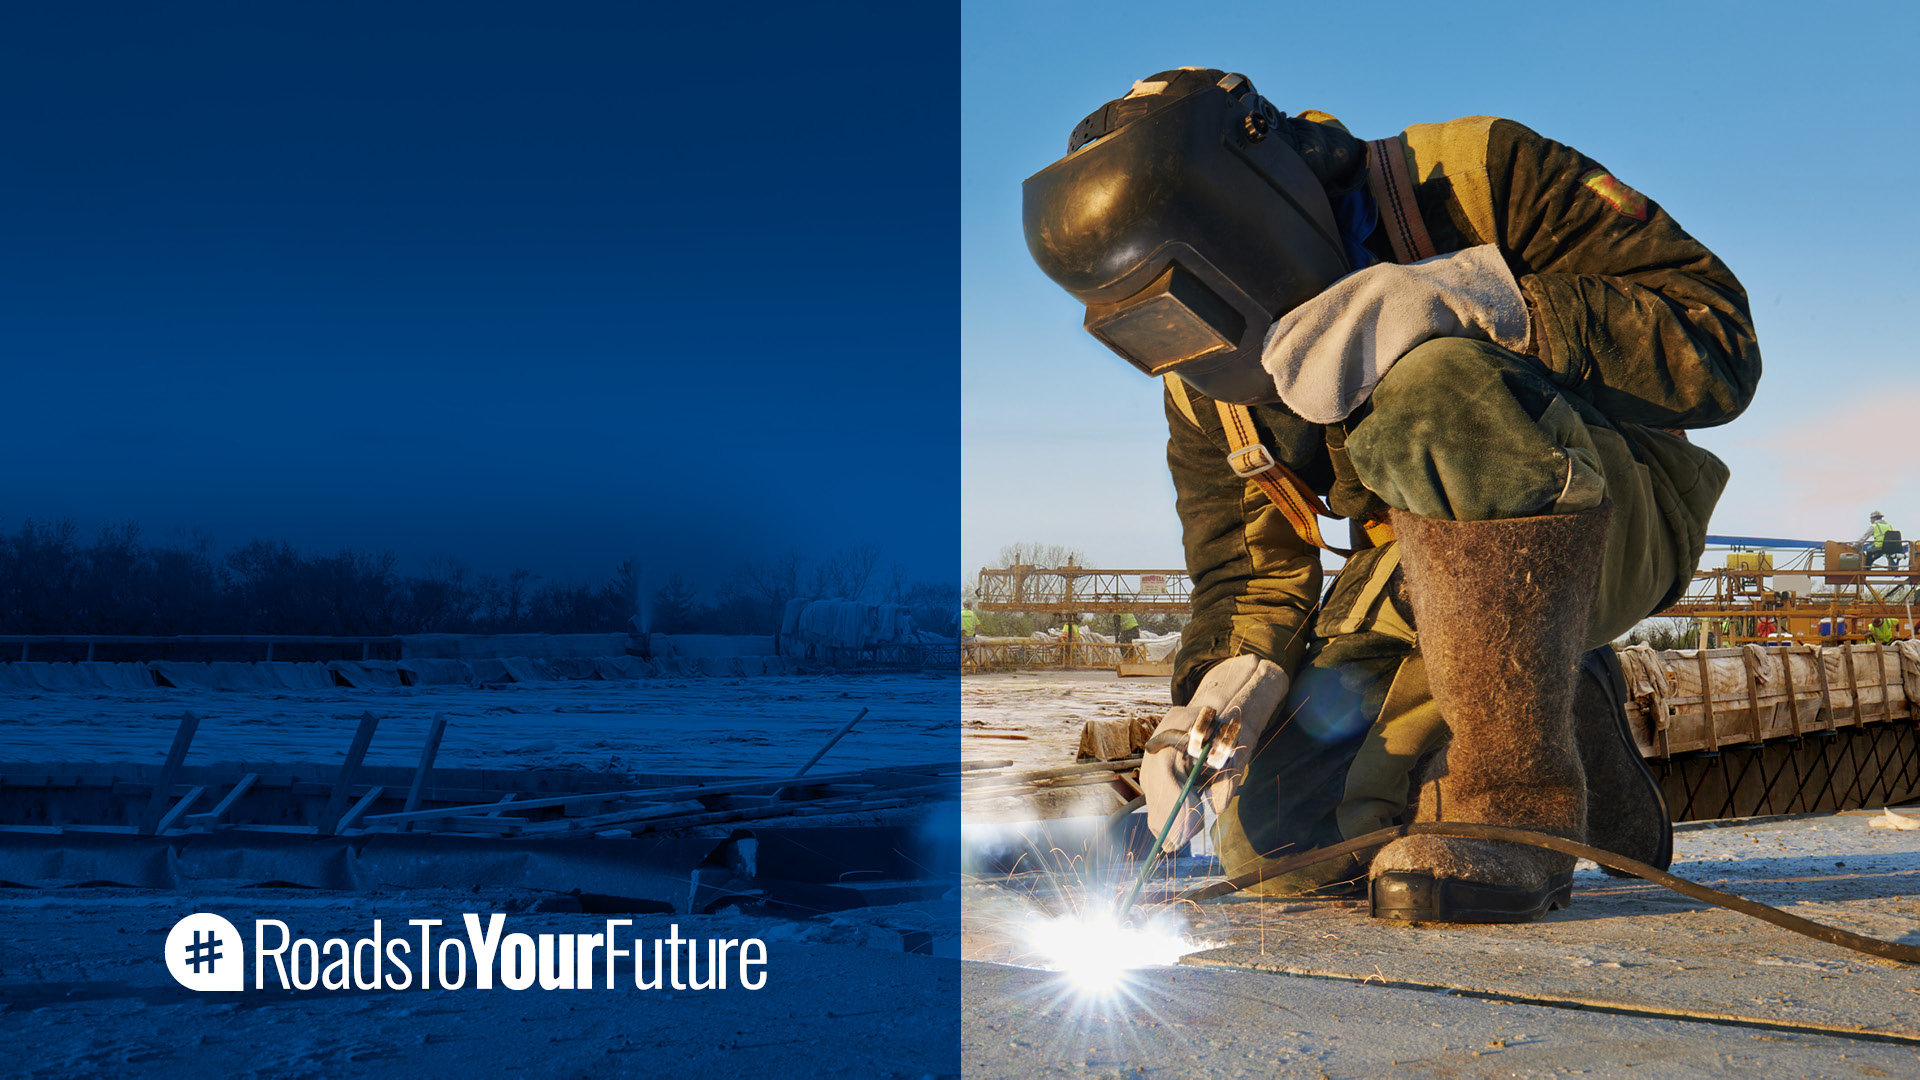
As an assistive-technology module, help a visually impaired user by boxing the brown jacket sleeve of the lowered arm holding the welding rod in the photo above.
[1167,382,1321,705]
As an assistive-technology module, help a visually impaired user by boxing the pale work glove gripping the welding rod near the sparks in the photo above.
[1140,655,1288,855]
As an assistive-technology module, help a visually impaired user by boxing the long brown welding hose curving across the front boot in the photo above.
[1177,821,1920,963]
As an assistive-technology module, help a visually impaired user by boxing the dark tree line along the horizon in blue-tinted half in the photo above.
[0,521,958,636]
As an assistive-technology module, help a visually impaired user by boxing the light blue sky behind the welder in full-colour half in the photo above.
[960,0,1920,575]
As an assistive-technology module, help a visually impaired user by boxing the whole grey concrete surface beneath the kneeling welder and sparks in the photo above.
[962,749,1920,1078]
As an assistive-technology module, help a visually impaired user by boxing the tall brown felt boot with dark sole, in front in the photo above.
[1371,503,1613,922]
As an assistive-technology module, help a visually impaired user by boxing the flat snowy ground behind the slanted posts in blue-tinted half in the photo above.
[0,673,956,774]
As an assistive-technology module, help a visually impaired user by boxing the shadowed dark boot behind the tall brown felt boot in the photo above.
[1572,646,1674,876]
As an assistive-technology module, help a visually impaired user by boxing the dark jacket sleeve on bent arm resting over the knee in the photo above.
[1488,121,1761,427]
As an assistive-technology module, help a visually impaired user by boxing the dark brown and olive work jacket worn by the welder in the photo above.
[1165,113,1761,703]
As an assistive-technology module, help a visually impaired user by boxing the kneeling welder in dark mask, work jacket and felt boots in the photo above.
[1023,67,1761,922]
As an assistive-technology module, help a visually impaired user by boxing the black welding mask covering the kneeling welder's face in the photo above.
[1021,69,1348,405]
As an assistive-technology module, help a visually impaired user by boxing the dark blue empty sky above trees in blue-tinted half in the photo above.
[0,2,958,580]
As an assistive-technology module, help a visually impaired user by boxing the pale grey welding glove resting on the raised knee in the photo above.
[1260,244,1528,423]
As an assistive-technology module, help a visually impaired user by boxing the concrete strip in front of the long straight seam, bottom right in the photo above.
[960,963,1920,1080]
